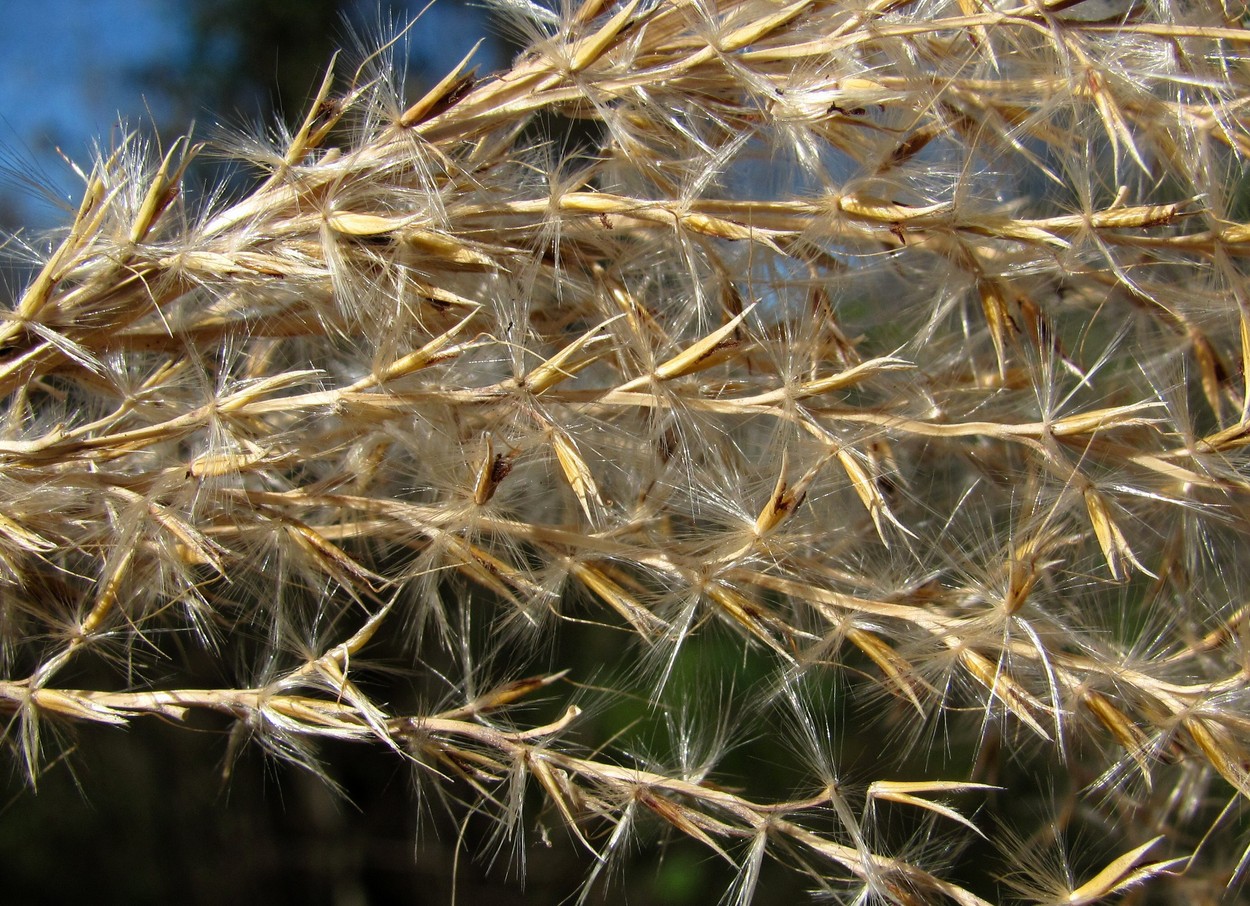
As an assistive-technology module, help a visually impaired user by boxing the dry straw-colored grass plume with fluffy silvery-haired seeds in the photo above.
[0,0,1250,906]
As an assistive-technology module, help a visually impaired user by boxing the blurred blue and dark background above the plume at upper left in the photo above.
[0,0,515,234]
